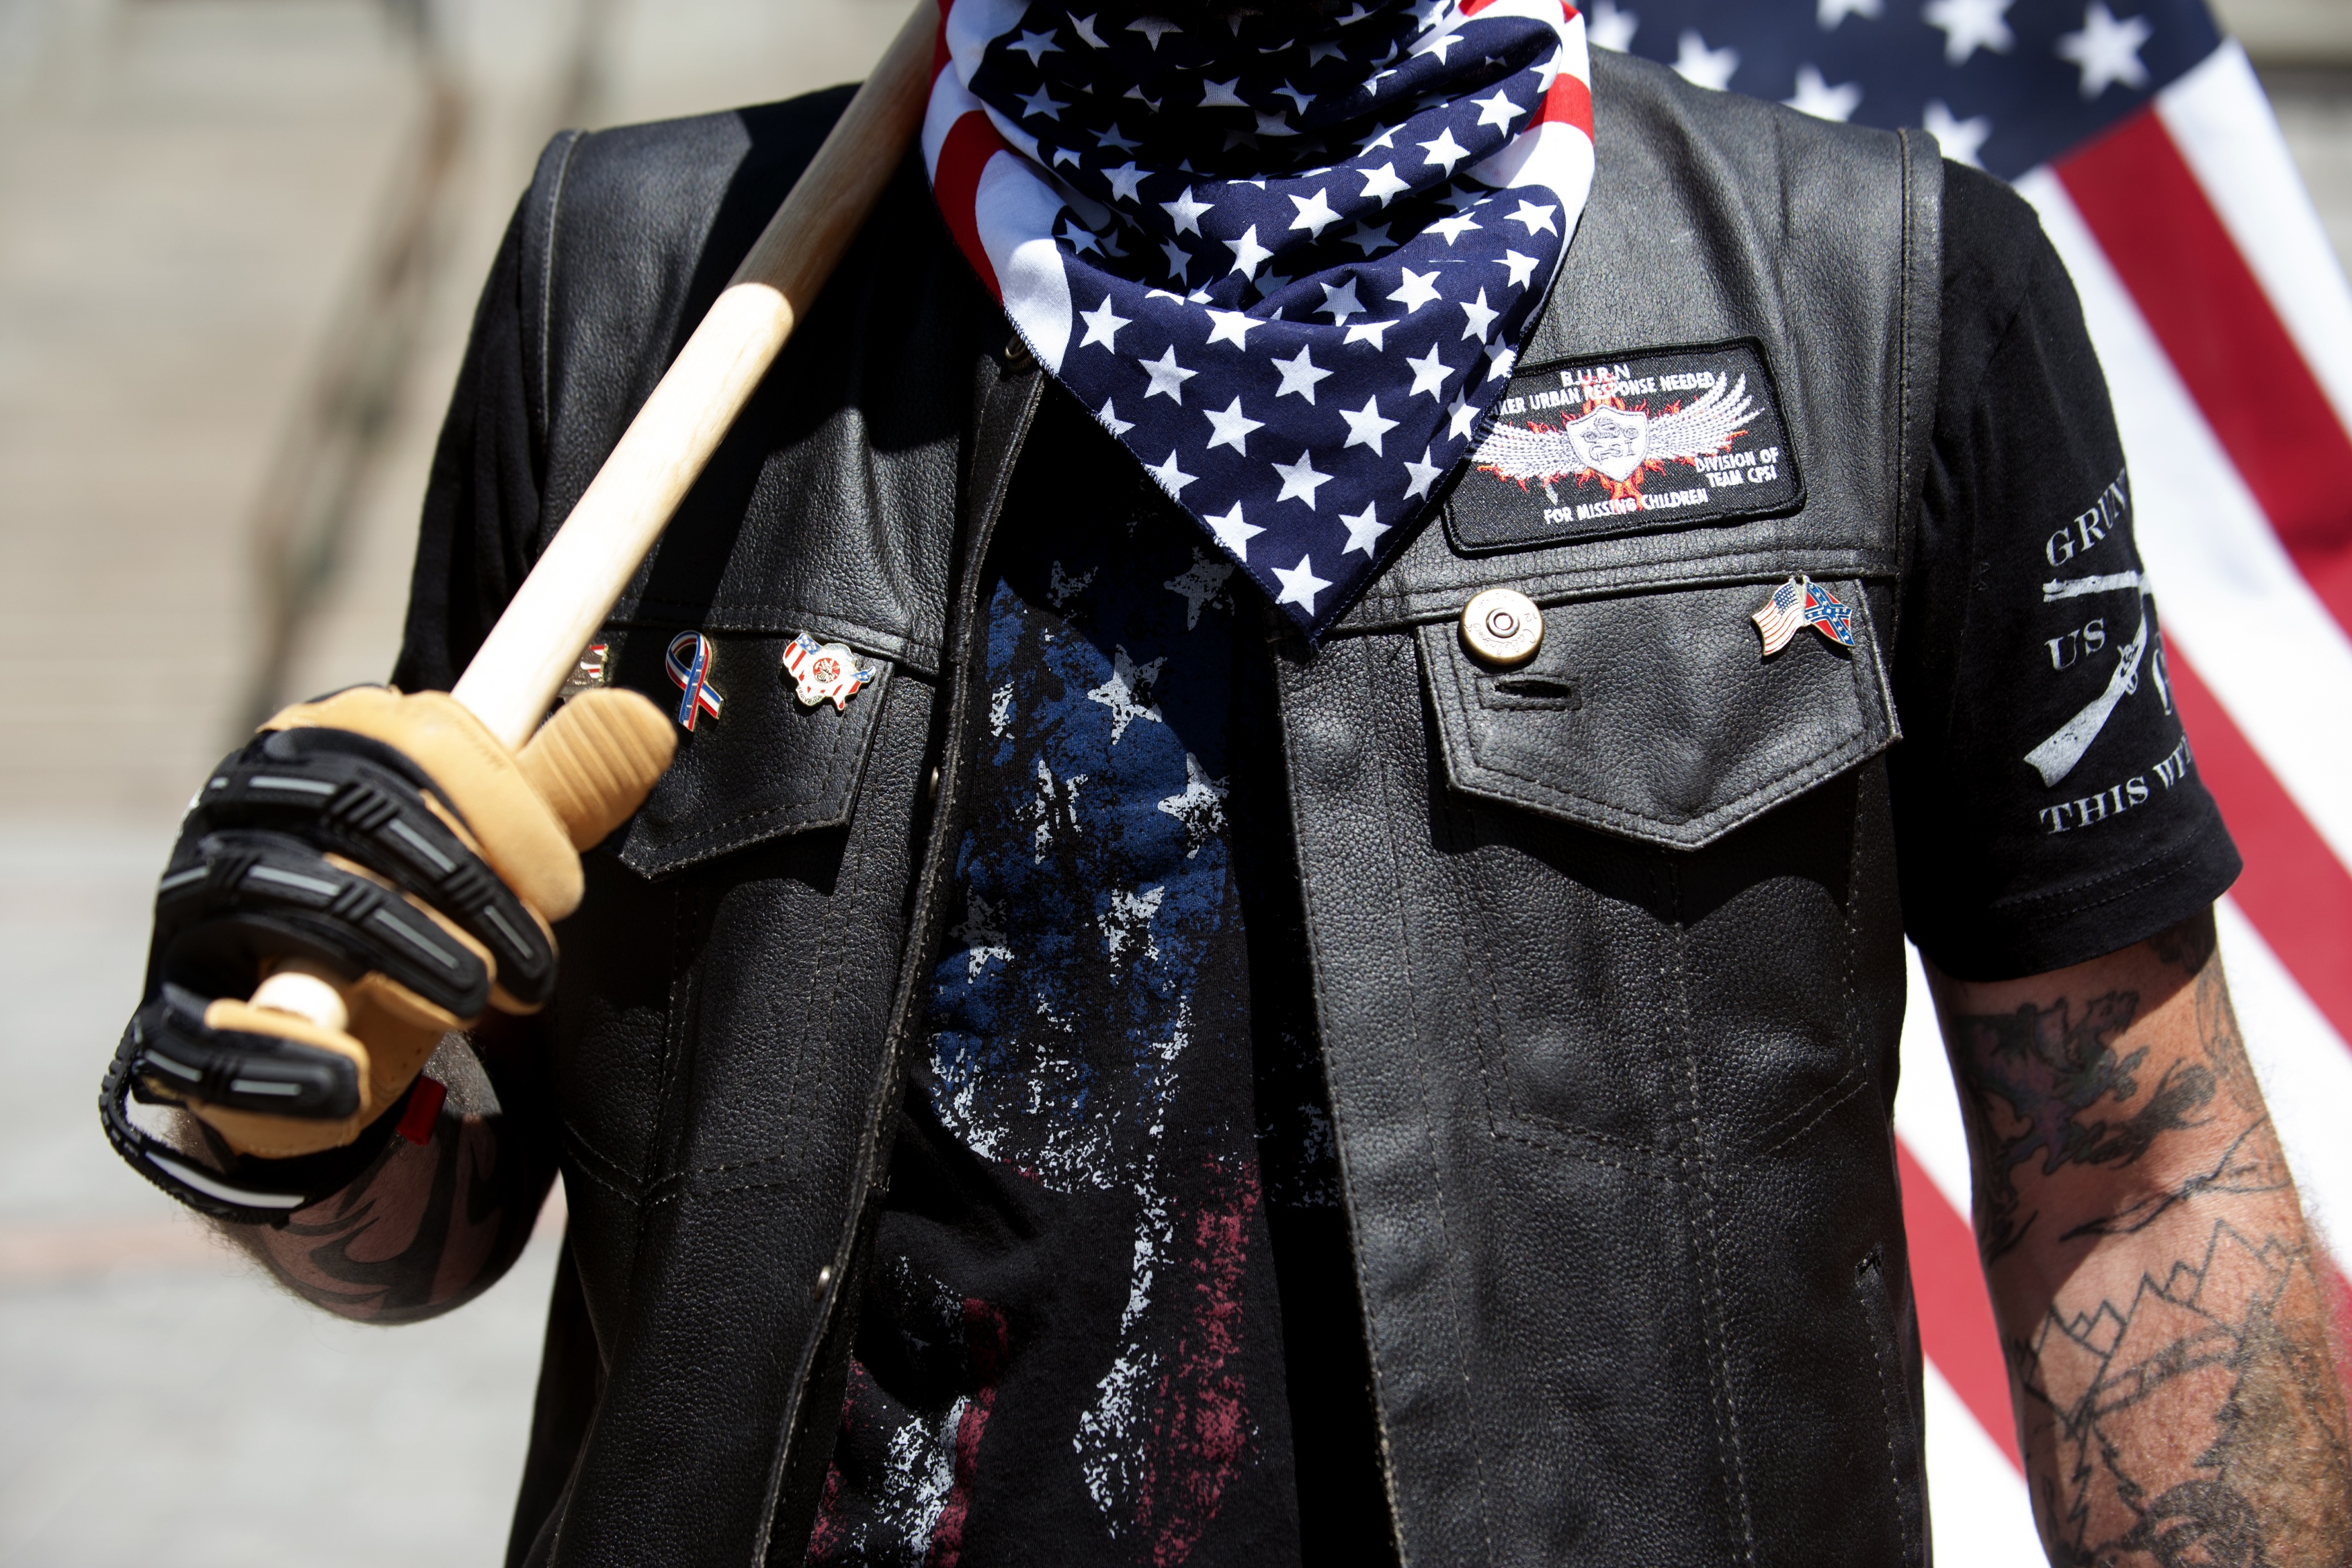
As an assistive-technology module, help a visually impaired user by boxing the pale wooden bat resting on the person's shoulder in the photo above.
[252,0,939,1030]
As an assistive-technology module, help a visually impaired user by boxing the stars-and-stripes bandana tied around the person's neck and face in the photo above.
[922,0,1593,642]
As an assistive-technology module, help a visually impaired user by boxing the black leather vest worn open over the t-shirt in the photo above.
[487,42,1943,1566]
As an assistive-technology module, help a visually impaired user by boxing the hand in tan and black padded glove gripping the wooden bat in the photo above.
[101,687,677,1220]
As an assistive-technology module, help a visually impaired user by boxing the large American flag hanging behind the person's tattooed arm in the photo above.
[1588,0,2352,1568]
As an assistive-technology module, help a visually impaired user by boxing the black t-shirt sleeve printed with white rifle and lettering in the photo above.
[1891,165,2239,980]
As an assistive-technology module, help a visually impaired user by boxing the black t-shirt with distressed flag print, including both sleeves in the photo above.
[395,156,2239,1568]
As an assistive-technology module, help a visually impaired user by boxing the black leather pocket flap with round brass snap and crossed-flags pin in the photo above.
[1419,580,1898,848]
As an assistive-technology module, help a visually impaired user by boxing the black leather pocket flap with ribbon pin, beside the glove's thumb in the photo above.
[576,625,892,877]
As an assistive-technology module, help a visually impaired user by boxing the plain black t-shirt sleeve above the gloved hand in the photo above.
[393,195,541,691]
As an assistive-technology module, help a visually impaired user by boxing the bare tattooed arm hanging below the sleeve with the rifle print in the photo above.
[1938,919,2352,1568]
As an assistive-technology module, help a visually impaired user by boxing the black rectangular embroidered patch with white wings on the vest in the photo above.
[1447,339,1804,555]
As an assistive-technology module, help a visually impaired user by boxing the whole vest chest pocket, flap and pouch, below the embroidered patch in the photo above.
[1416,578,1896,1176]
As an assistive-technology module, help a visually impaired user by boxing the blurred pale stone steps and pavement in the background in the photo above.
[0,0,2352,1568]
